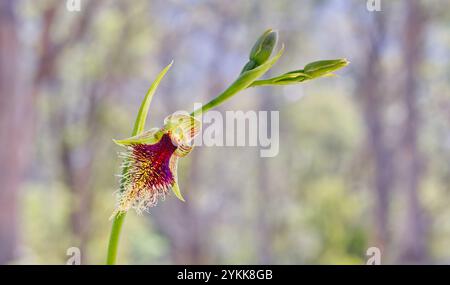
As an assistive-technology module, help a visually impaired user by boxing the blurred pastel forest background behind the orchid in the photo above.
[0,0,450,264]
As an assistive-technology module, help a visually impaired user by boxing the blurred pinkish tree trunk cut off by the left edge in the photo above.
[0,0,21,264]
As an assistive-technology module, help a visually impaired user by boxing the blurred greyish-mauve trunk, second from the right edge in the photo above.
[357,13,393,249]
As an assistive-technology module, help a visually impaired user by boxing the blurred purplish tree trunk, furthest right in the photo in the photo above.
[399,0,426,263]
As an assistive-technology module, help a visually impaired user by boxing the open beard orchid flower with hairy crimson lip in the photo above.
[113,112,201,216]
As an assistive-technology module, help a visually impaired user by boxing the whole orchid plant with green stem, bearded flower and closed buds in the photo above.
[106,29,348,264]
